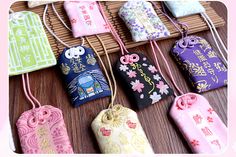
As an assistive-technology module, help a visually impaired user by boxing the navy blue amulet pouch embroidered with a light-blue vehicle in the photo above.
[58,46,111,106]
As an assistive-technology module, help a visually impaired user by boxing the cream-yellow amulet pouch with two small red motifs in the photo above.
[91,105,154,154]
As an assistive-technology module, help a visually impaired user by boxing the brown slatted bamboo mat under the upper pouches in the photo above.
[11,1,225,56]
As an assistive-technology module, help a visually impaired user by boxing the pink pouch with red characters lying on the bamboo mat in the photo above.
[64,1,109,38]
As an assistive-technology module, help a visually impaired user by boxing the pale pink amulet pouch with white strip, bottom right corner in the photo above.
[170,93,227,153]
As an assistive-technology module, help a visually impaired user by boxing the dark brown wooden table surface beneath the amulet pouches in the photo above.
[9,2,227,153]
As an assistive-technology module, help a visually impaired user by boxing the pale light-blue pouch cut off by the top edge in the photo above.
[164,0,205,18]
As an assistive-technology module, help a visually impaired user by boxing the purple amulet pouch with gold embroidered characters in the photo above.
[171,36,227,93]
